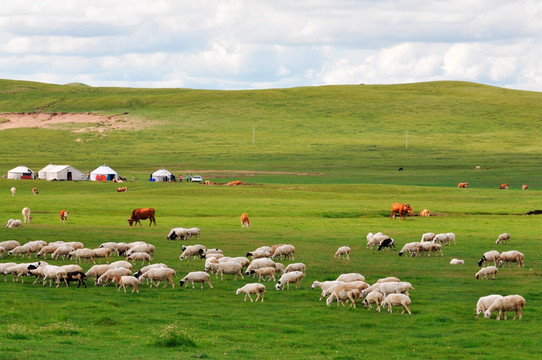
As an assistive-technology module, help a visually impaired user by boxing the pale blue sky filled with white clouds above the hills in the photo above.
[0,0,542,91]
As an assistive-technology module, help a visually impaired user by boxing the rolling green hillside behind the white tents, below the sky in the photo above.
[0,80,542,188]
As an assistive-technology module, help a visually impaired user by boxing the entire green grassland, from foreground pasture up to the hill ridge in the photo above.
[0,81,542,360]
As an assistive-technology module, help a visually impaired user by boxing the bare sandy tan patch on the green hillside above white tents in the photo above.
[0,112,143,132]
